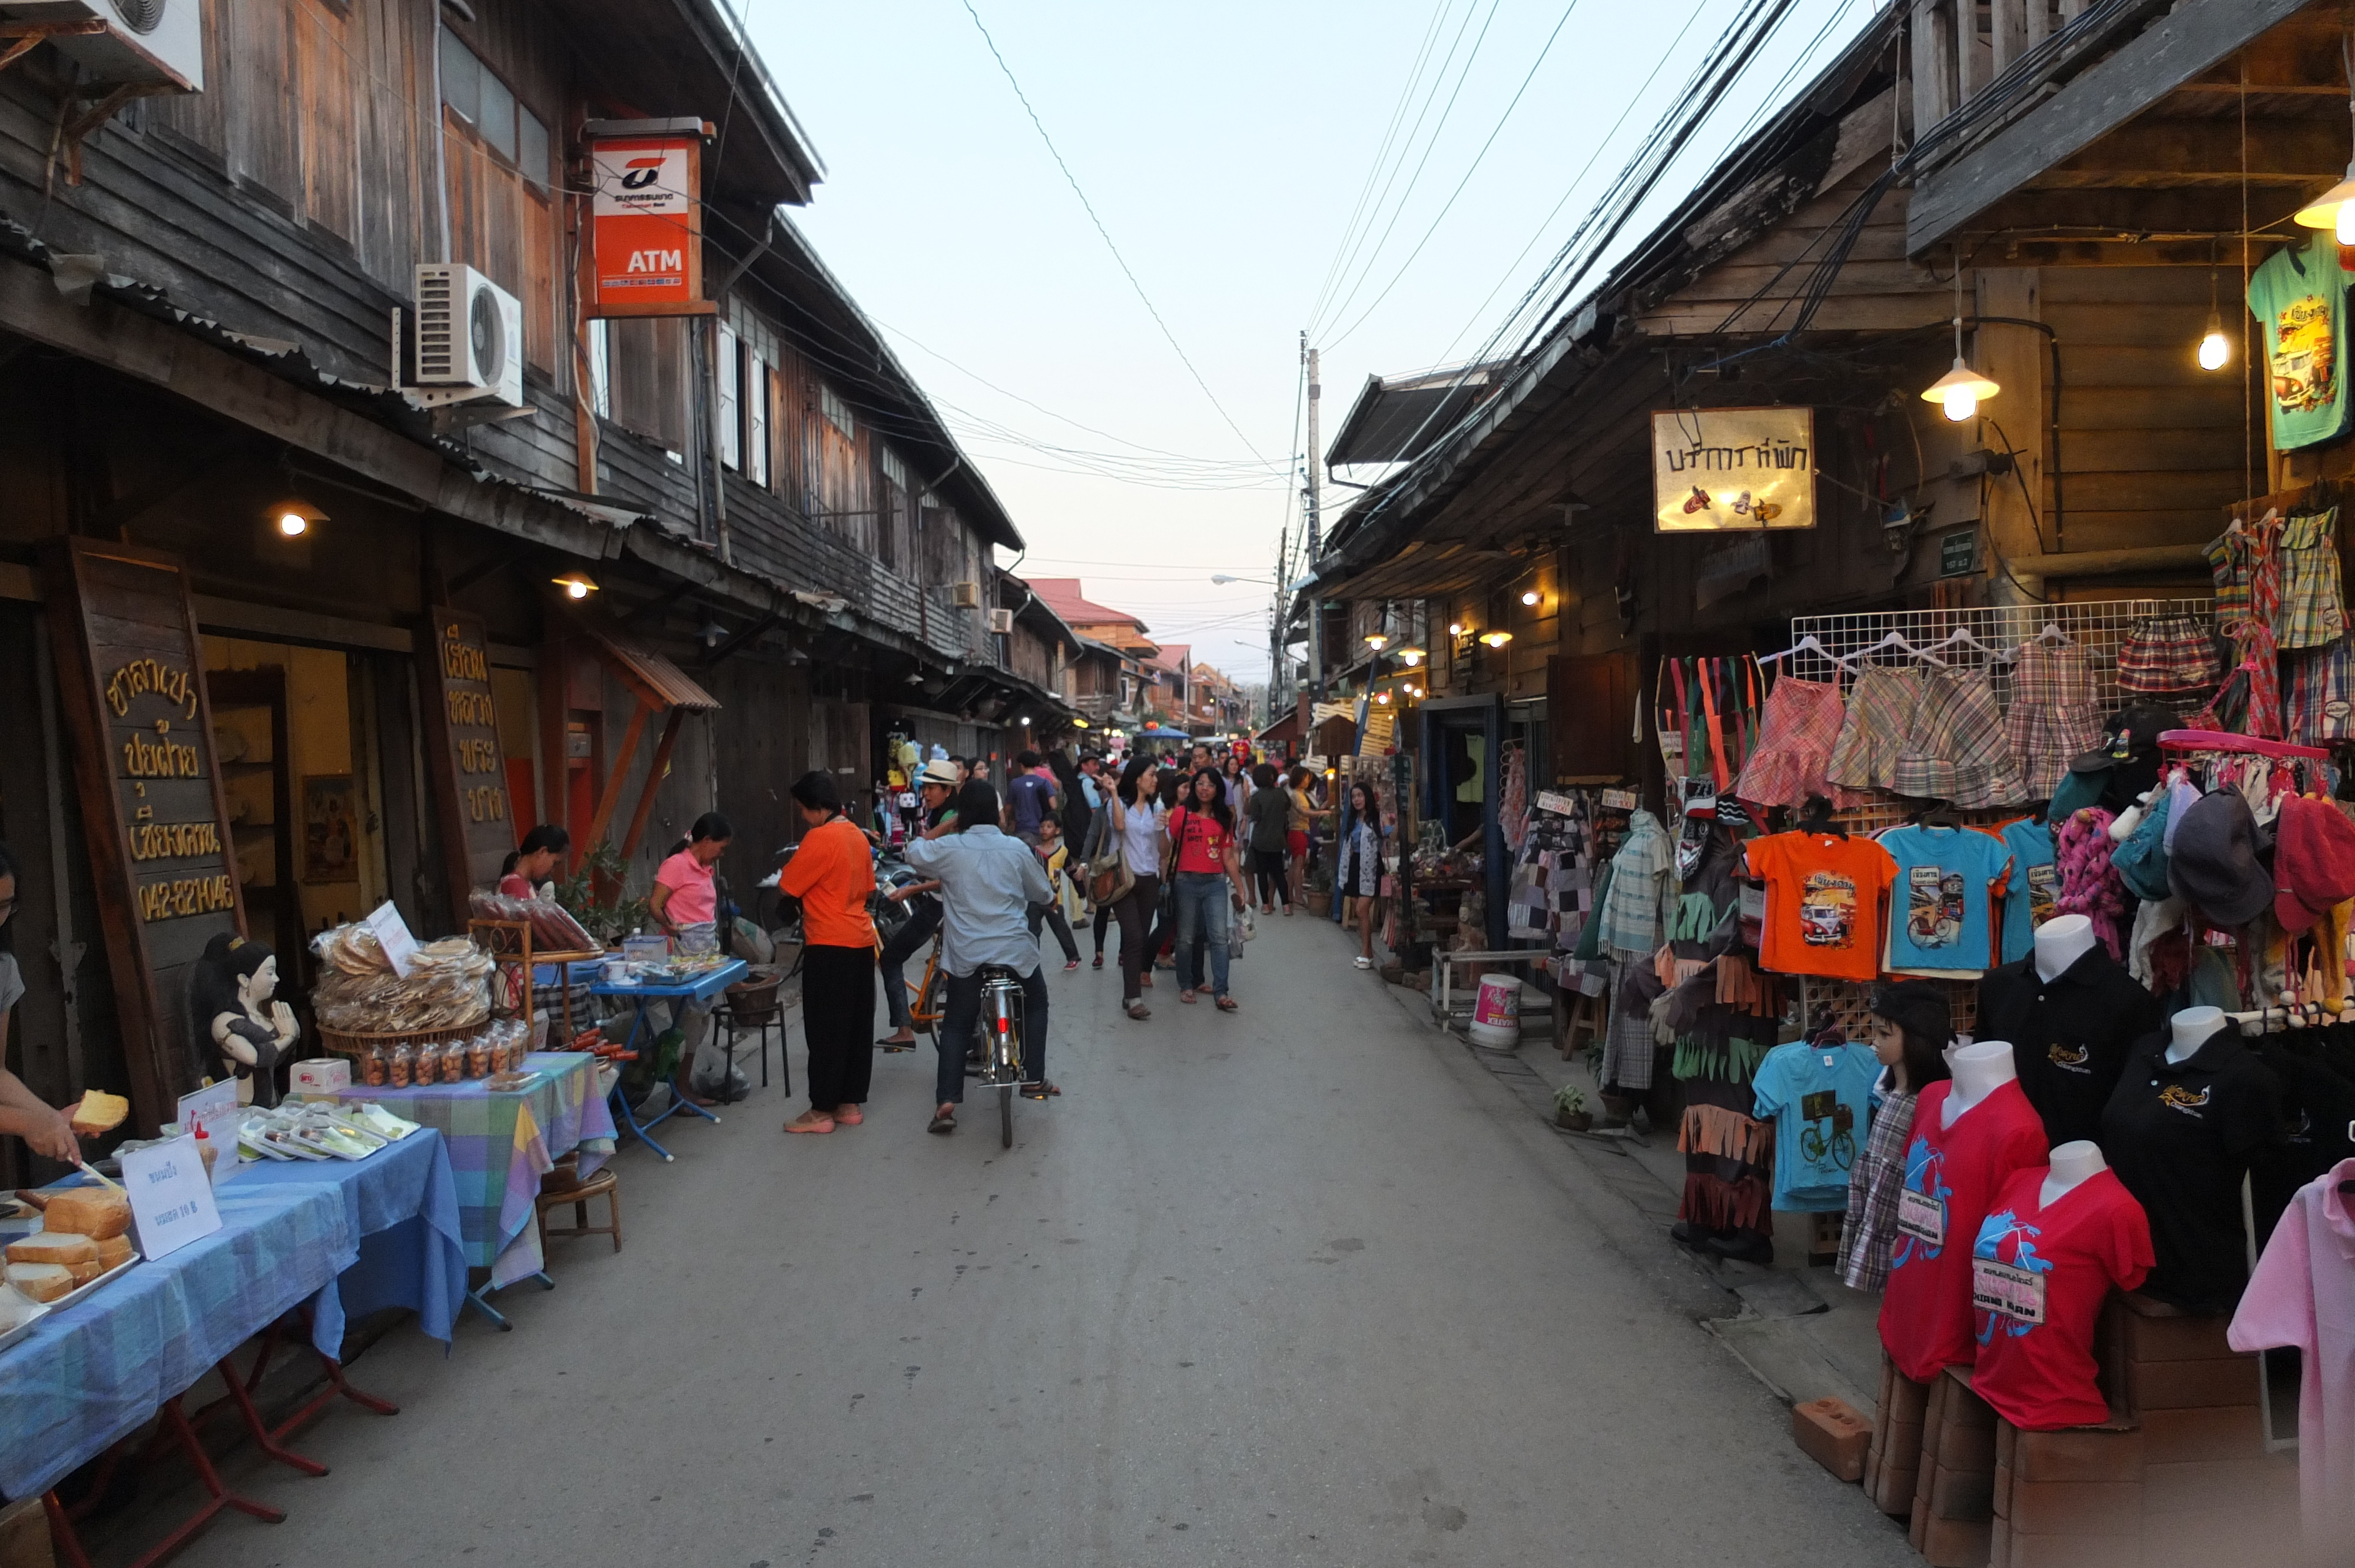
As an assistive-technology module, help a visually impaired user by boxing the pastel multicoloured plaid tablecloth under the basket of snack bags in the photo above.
[344,1050,612,1285]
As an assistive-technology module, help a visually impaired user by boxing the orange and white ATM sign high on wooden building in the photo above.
[584,134,711,315]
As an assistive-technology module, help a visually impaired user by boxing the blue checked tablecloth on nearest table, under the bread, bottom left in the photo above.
[0,1182,360,1497]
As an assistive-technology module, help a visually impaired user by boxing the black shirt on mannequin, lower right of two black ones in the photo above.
[2101,1024,2282,1311]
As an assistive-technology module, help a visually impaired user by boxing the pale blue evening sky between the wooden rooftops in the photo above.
[744,0,1877,683]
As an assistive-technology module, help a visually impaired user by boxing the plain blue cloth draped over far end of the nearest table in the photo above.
[226,1128,466,1358]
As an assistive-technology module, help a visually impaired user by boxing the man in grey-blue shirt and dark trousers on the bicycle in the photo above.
[907,779,1062,1132]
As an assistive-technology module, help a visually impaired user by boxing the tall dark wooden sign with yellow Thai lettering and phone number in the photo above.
[42,539,244,1137]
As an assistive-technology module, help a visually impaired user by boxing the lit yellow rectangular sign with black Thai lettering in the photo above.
[1651,407,1816,534]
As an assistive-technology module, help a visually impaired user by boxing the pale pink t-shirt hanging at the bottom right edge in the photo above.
[2225,1161,2355,1561]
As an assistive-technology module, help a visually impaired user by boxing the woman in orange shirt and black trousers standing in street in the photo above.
[777,768,876,1132]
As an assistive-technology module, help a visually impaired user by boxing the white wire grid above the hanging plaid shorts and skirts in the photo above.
[1780,598,2214,713]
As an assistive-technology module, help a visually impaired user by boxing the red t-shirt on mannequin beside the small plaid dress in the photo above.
[1882,1078,2046,1382]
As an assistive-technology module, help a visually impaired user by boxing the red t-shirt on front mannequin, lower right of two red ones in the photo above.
[1971,1158,2155,1431]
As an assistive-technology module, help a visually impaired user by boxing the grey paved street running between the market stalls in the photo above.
[184,918,1915,1568]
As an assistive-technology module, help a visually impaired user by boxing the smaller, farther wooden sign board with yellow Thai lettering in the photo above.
[417,607,516,930]
